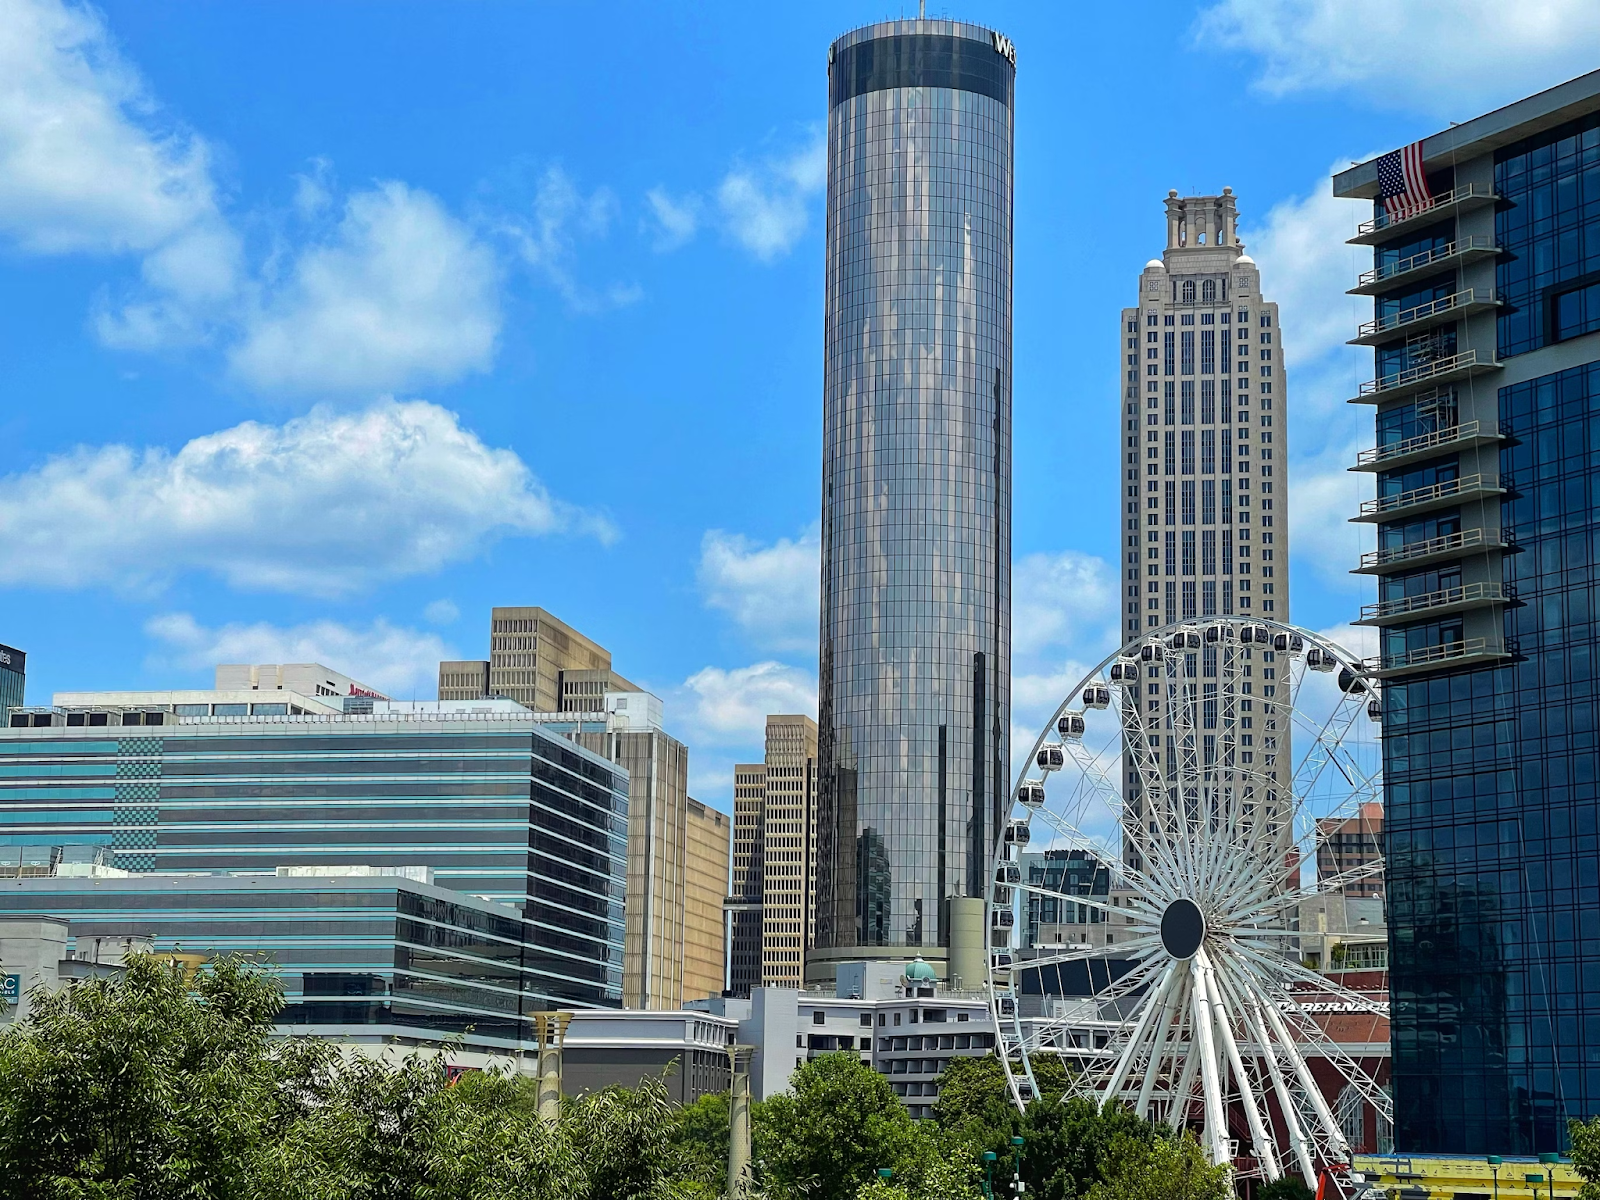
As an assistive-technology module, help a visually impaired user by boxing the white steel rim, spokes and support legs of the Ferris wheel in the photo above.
[984,616,1394,1187]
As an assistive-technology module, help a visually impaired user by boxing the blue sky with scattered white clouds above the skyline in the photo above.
[0,0,1600,806]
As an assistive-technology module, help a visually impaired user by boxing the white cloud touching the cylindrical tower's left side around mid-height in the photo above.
[699,525,821,651]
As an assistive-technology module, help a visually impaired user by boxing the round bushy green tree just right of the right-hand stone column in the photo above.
[754,1053,925,1200]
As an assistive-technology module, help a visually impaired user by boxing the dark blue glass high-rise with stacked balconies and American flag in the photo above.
[1333,72,1600,1154]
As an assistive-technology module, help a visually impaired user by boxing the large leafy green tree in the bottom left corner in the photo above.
[0,955,283,1200]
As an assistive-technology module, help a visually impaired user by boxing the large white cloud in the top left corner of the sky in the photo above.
[0,0,240,346]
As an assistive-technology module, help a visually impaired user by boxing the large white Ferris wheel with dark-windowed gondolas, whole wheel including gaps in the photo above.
[987,618,1394,1187]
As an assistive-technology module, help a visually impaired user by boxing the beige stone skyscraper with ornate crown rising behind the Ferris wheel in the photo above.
[1122,187,1293,864]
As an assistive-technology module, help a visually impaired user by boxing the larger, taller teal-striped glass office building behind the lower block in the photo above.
[0,701,629,1027]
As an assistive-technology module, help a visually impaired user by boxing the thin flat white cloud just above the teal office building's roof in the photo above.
[144,613,456,699]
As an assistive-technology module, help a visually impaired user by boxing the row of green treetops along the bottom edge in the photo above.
[0,955,1235,1200]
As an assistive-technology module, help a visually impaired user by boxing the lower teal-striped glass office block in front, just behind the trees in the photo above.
[0,867,549,1064]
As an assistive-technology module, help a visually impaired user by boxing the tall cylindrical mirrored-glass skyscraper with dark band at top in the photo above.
[806,19,1016,979]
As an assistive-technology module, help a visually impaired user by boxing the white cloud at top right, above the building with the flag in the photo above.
[1195,0,1600,120]
